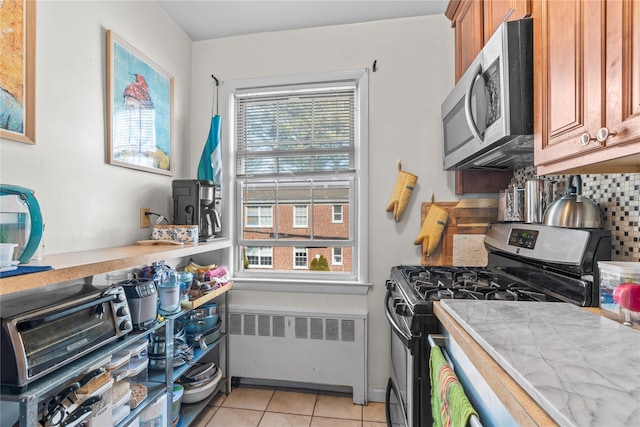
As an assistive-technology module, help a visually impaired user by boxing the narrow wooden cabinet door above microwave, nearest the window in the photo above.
[446,0,484,82]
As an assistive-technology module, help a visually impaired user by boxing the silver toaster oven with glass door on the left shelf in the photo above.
[0,284,133,391]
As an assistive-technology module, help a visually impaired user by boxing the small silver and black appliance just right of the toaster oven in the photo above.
[118,278,158,331]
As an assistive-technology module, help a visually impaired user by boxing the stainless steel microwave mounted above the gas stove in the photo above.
[442,19,533,170]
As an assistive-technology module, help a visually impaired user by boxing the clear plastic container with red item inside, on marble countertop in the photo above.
[598,261,640,329]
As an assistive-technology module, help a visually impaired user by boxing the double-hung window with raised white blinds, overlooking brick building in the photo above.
[232,71,367,283]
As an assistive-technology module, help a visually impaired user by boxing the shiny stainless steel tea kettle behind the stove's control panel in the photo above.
[543,175,603,228]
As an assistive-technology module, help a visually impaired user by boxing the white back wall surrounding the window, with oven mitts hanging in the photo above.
[191,15,458,400]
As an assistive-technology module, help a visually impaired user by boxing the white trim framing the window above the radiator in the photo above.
[220,69,373,295]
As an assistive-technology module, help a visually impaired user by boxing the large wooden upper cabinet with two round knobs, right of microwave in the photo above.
[532,0,640,175]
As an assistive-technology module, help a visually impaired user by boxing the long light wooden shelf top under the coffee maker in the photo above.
[0,238,231,295]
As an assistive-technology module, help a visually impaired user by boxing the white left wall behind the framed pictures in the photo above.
[0,0,192,254]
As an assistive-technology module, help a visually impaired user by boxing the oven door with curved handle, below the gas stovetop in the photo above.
[385,290,419,427]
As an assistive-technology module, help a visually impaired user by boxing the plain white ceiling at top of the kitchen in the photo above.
[158,0,449,41]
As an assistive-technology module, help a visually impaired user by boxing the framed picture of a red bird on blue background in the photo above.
[107,30,173,175]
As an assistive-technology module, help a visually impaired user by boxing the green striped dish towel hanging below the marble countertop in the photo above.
[429,346,478,427]
